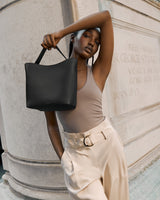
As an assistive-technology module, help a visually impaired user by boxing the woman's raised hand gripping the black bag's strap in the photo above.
[41,32,62,50]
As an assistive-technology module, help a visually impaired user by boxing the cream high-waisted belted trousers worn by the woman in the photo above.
[61,117,129,200]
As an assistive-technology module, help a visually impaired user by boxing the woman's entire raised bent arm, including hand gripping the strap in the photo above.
[41,10,114,85]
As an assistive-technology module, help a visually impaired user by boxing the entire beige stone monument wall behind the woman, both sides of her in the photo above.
[0,0,160,200]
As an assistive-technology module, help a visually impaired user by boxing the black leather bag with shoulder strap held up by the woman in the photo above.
[25,47,77,111]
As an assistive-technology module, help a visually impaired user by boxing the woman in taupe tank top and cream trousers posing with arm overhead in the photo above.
[41,11,129,200]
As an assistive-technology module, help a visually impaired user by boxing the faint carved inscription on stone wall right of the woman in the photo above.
[113,43,160,100]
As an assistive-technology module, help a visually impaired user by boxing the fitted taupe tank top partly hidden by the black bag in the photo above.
[56,66,105,133]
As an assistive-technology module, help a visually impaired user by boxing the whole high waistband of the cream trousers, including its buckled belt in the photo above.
[63,116,113,148]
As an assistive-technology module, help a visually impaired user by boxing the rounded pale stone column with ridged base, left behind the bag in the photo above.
[0,0,72,200]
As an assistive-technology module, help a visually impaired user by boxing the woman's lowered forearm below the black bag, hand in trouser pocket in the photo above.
[45,111,64,159]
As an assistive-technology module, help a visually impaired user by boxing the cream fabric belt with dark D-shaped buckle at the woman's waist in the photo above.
[64,126,113,148]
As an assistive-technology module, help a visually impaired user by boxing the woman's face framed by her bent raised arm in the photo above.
[73,29,100,59]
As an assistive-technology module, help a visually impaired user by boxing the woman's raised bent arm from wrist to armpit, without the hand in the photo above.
[59,11,114,72]
